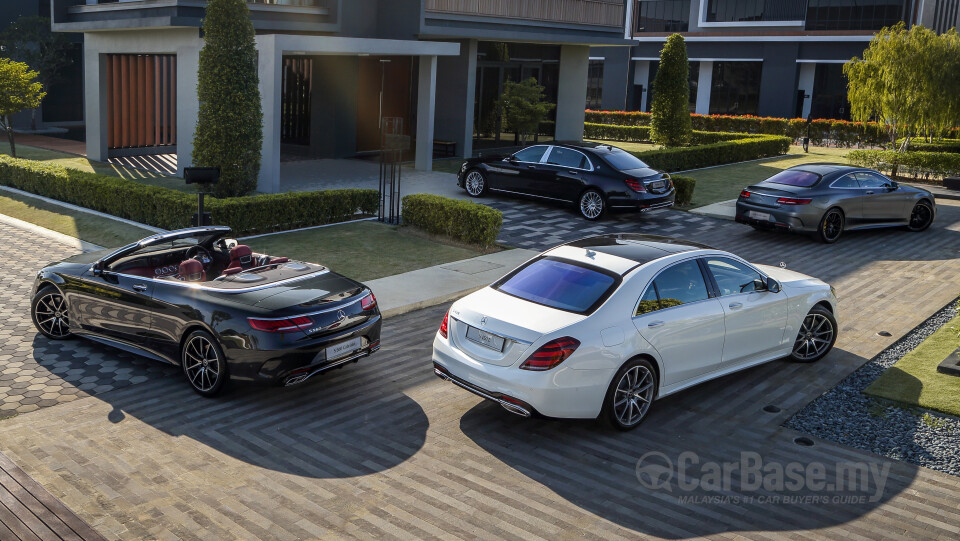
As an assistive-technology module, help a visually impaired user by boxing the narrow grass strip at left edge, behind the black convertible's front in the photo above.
[0,191,153,248]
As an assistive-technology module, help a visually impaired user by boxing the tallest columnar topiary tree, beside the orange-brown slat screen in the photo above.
[193,0,263,197]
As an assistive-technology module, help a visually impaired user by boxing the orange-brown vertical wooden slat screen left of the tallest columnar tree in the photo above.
[106,54,177,149]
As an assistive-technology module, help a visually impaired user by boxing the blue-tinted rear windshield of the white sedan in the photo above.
[495,257,620,314]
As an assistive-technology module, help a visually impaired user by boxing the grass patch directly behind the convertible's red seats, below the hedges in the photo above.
[245,221,481,281]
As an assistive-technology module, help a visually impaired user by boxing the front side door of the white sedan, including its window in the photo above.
[703,256,789,366]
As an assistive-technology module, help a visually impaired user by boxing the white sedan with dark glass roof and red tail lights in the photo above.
[433,234,838,430]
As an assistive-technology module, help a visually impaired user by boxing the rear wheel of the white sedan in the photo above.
[600,359,657,430]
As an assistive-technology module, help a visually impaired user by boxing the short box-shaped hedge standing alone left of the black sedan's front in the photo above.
[403,193,503,247]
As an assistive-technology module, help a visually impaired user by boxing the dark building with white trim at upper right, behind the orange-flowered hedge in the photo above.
[591,0,960,118]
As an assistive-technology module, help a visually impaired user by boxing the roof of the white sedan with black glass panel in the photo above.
[546,233,713,274]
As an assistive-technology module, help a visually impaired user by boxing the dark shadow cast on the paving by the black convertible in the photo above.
[34,336,429,478]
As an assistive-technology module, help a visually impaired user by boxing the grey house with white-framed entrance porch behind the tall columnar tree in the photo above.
[51,0,632,192]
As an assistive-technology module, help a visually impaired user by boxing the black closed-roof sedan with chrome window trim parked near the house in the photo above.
[457,142,676,220]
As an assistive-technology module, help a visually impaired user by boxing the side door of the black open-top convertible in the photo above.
[72,269,154,347]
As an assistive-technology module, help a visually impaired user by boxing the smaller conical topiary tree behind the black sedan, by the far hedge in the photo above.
[650,34,693,147]
